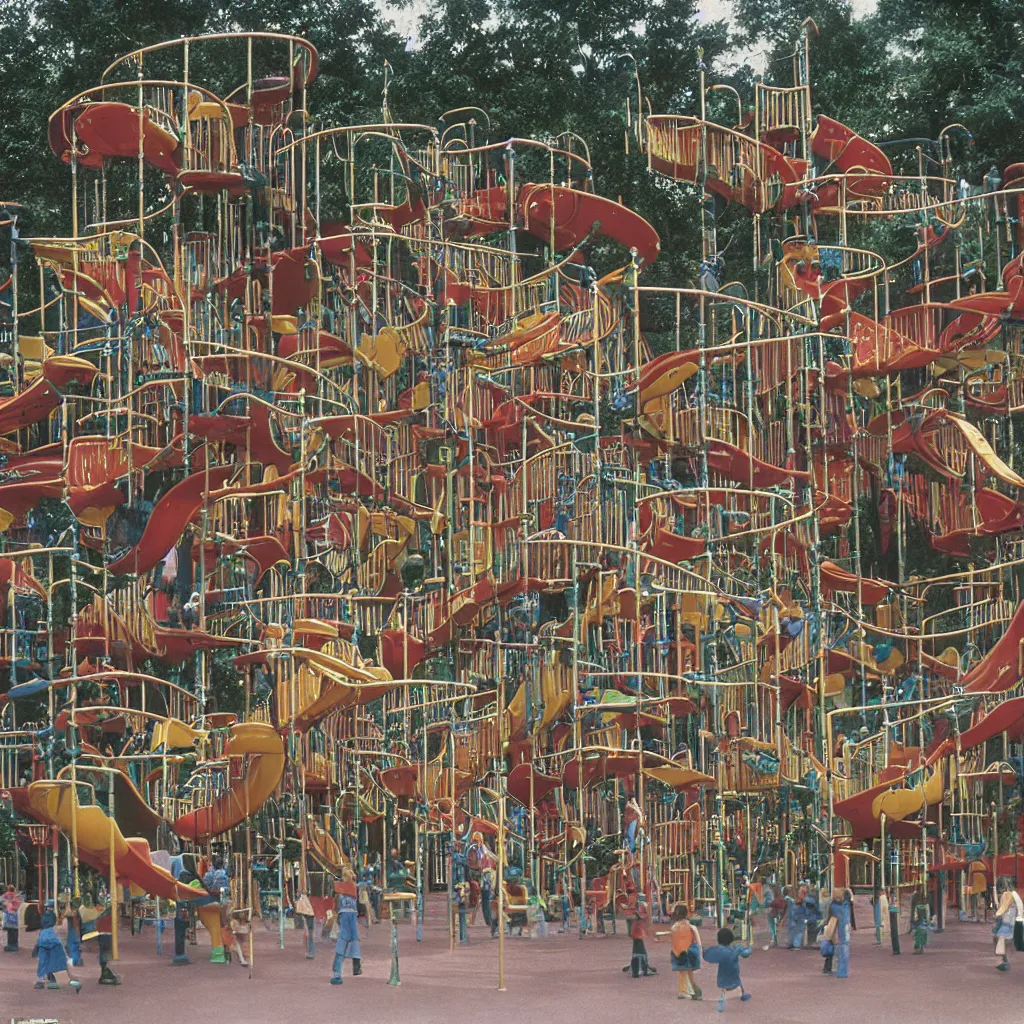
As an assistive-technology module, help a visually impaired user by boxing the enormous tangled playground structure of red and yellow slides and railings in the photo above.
[0,23,1024,974]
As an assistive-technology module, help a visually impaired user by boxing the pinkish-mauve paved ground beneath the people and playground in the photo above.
[0,900,1024,1024]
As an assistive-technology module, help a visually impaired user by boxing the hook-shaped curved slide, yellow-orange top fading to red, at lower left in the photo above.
[172,722,285,843]
